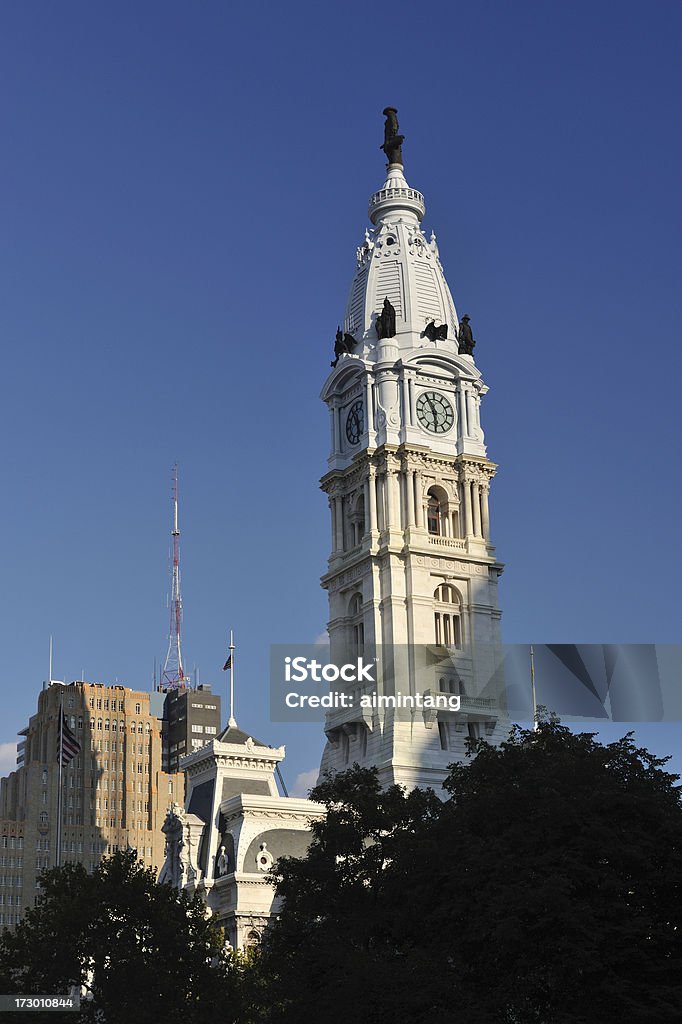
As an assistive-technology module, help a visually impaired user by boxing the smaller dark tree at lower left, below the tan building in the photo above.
[0,851,230,1024]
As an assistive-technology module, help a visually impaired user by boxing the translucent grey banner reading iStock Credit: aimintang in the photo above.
[270,643,682,729]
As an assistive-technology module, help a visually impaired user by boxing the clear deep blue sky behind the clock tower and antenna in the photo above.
[0,0,682,783]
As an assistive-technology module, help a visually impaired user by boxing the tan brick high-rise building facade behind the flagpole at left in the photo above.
[0,682,184,926]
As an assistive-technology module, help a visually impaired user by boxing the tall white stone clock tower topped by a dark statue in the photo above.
[322,108,508,788]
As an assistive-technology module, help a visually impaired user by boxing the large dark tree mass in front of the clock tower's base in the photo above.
[244,719,682,1024]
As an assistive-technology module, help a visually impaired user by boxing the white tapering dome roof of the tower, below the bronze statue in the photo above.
[344,164,459,359]
